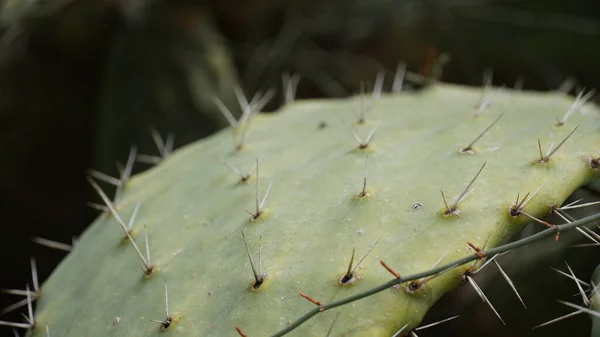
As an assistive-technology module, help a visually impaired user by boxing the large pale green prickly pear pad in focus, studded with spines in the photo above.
[32,84,600,337]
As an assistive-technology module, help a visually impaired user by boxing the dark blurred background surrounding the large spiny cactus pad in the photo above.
[0,0,600,336]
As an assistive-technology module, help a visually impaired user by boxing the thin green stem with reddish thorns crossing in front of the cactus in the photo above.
[271,209,600,337]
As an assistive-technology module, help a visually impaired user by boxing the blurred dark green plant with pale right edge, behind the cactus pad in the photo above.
[94,3,241,172]
